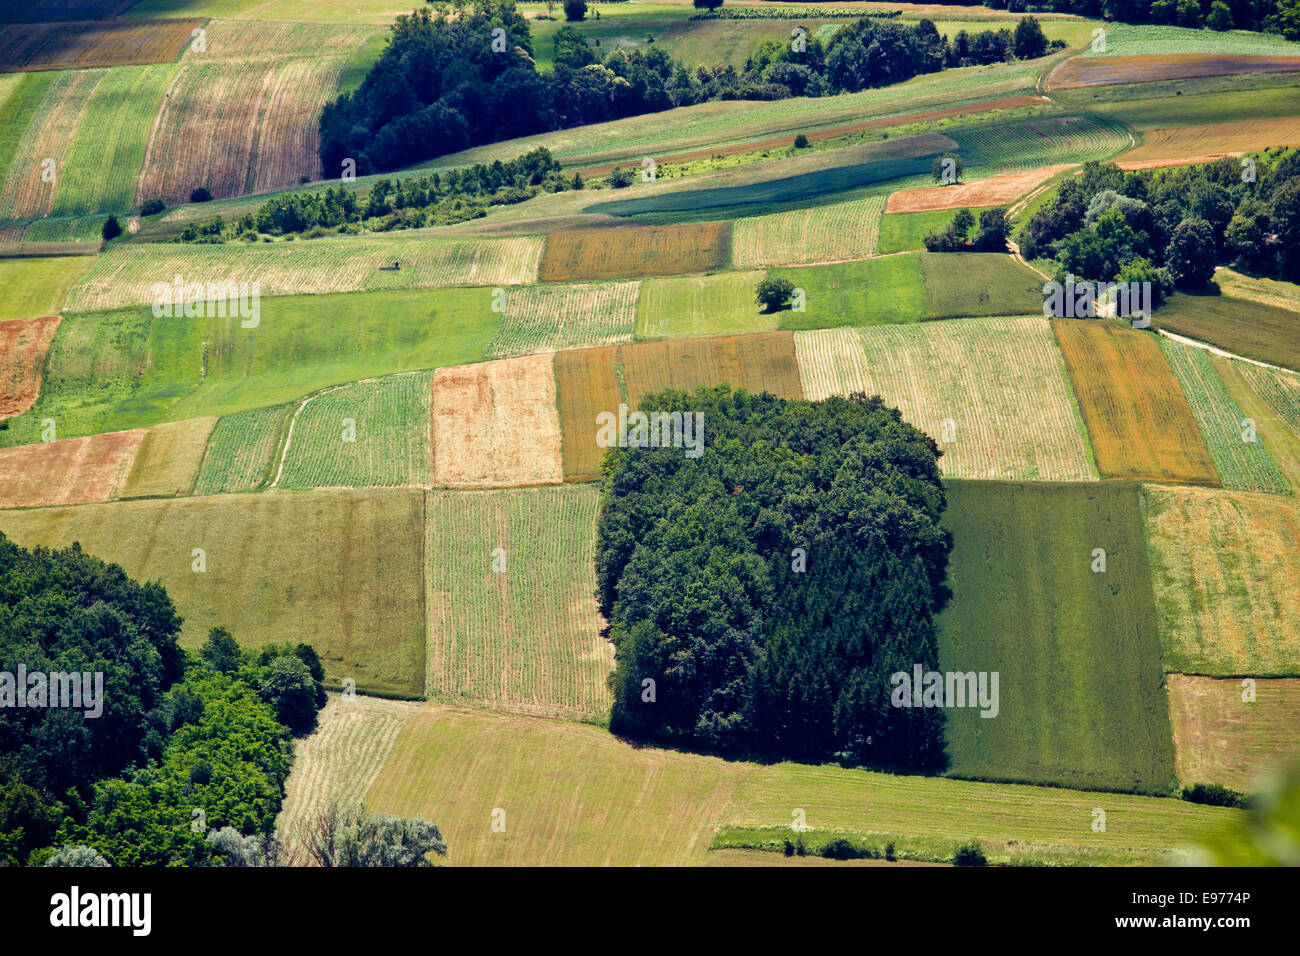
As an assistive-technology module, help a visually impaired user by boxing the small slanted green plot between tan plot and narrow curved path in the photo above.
[194,405,298,494]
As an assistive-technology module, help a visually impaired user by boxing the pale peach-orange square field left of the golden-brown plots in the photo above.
[429,354,564,488]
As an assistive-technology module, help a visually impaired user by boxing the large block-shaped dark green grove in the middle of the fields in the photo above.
[597,386,950,770]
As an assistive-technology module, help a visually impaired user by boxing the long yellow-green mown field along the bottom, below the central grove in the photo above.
[358,706,1242,866]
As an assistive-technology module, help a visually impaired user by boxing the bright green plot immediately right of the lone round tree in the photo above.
[771,255,926,329]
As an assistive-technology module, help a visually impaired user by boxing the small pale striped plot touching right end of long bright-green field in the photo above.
[488,282,641,359]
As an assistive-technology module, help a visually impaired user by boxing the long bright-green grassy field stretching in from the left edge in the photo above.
[0,290,501,445]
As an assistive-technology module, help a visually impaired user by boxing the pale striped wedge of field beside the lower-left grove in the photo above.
[276,695,423,855]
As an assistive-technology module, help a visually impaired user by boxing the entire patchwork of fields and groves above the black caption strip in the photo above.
[0,0,1300,879]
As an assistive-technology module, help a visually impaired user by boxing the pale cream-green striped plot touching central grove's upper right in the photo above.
[794,316,1096,481]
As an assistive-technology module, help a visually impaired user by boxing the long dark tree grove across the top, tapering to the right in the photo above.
[320,0,1048,176]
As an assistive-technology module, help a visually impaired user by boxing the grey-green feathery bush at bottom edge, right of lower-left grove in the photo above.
[303,804,447,868]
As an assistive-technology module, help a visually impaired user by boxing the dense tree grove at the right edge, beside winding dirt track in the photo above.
[1021,150,1300,293]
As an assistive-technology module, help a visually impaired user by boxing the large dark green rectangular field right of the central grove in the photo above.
[939,481,1177,793]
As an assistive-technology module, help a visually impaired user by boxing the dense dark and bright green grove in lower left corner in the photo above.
[0,535,324,866]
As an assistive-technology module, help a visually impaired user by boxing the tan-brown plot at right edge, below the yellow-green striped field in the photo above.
[1169,674,1300,793]
